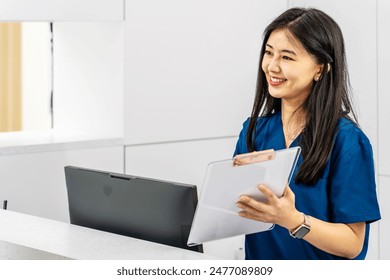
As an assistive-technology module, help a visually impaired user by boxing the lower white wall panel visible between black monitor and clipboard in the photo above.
[125,137,237,195]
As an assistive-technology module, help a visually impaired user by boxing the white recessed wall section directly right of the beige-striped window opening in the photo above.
[53,22,123,137]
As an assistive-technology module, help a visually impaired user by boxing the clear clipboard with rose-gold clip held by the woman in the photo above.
[187,147,301,246]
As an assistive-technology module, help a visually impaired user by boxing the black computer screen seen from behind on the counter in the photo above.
[64,166,203,252]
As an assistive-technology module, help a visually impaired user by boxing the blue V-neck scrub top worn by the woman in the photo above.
[235,111,381,260]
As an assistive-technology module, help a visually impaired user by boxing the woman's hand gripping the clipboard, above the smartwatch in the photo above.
[237,185,303,230]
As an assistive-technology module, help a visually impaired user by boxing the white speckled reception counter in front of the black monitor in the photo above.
[0,210,215,260]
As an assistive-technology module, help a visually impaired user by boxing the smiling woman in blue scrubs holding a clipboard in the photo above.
[235,8,381,260]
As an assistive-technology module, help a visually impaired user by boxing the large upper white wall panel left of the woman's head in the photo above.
[125,0,286,145]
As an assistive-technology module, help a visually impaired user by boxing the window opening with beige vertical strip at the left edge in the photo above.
[0,22,52,132]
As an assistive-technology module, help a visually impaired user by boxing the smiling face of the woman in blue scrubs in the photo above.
[261,29,323,105]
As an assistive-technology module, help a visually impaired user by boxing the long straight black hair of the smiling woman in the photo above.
[246,8,357,184]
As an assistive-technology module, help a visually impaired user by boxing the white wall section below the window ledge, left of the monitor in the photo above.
[0,146,123,222]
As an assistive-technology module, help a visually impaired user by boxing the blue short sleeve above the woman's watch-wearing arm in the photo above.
[328,125,380,223]
